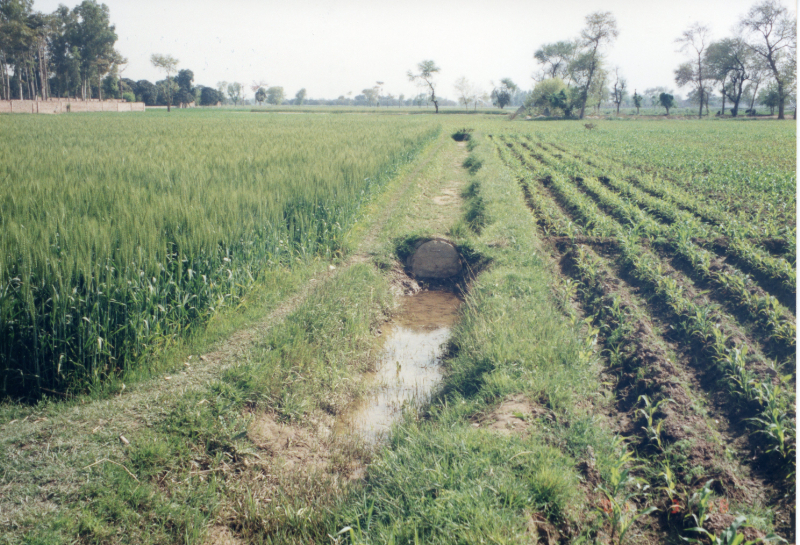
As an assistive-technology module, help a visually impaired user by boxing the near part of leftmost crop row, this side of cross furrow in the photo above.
[567,245,744,539]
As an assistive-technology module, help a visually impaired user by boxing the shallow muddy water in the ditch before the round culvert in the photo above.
[337,291,461,441]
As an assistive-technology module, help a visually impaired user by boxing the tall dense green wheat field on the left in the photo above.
[0,112,438,396]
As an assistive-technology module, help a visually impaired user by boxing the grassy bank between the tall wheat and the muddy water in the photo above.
[5,264,391,544]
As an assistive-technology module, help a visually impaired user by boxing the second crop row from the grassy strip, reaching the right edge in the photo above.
[494,136,794,464]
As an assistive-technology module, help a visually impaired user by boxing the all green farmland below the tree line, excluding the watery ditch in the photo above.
[0,108,797,545]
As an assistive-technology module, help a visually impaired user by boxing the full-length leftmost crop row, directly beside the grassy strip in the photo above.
[496,133,720,536]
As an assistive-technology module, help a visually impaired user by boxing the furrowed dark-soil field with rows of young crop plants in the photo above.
[490,130,796,540]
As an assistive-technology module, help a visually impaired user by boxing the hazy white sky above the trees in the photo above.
[34,0,796,99]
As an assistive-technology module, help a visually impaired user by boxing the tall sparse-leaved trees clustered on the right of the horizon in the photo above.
[525,0,797,119]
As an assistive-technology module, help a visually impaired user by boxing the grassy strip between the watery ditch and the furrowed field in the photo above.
[310,124,620,544]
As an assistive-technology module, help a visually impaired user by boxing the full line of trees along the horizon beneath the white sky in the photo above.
[0,0,797,119]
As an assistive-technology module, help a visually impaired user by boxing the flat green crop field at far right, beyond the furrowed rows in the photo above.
[537,123,796,227]
